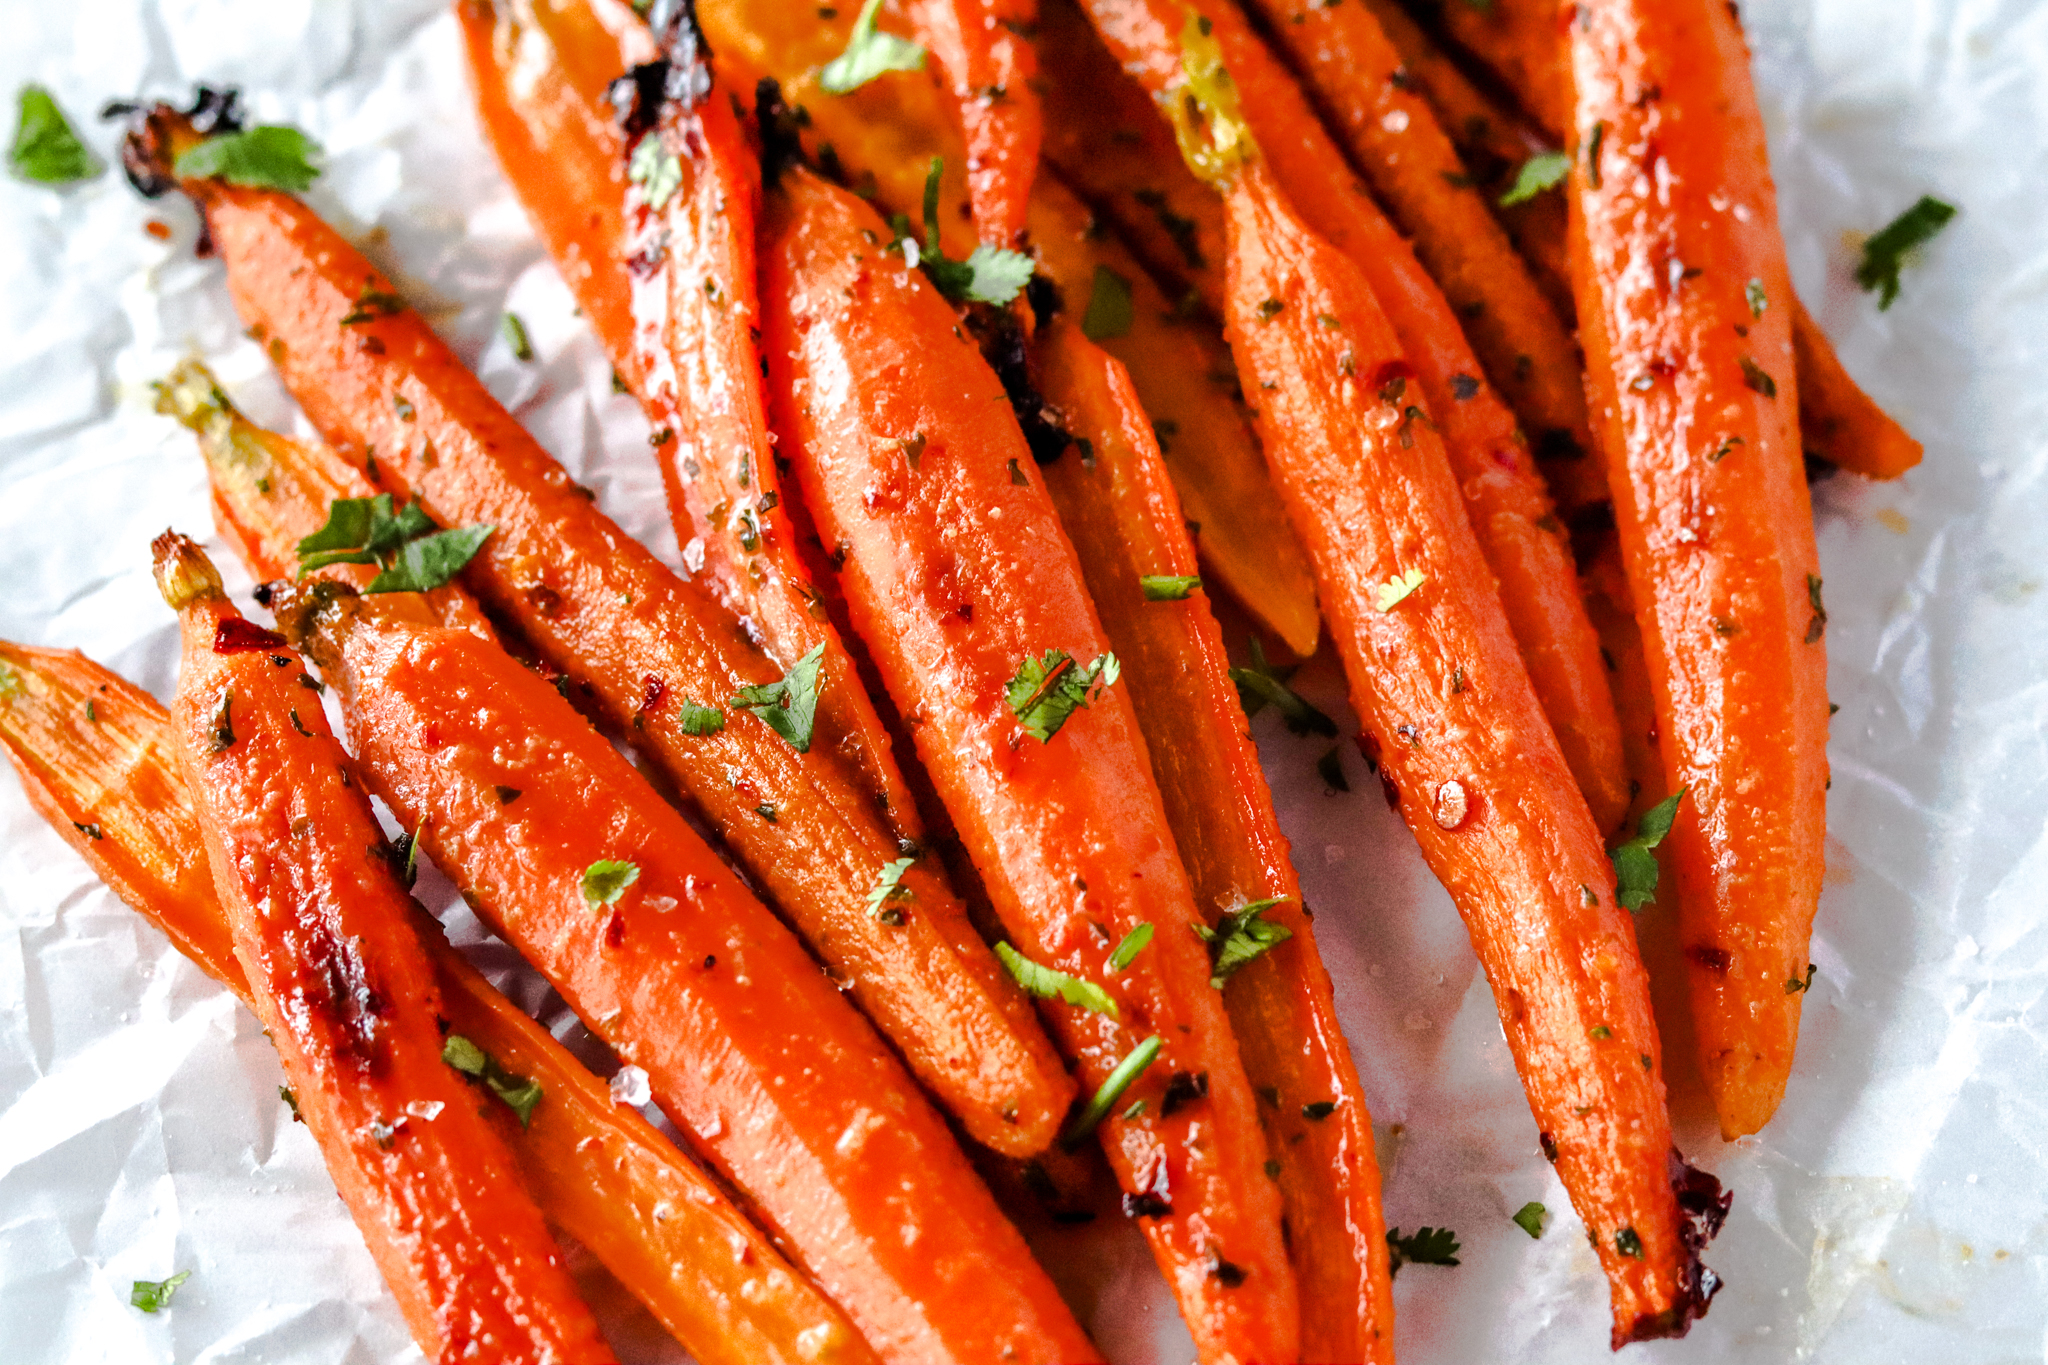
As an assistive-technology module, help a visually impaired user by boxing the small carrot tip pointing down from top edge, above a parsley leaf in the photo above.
[905,0,1042,248]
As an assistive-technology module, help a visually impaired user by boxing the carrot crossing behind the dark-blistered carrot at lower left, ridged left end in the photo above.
[0,643,874,1365]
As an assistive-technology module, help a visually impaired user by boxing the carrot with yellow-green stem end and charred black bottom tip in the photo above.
[1227,162,1716,1345]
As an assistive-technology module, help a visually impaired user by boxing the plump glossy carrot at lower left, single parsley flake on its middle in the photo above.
[279,583,1098,1365]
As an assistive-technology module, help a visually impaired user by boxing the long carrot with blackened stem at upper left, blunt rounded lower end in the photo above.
[121,101,1073,1154]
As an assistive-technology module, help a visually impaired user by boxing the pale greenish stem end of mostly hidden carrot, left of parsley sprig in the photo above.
[156,360,498,641]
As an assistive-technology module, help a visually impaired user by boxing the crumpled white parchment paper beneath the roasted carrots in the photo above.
[0,0,2048,1365]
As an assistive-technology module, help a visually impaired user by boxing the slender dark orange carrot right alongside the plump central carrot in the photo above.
[1034,317,1393,1363]
